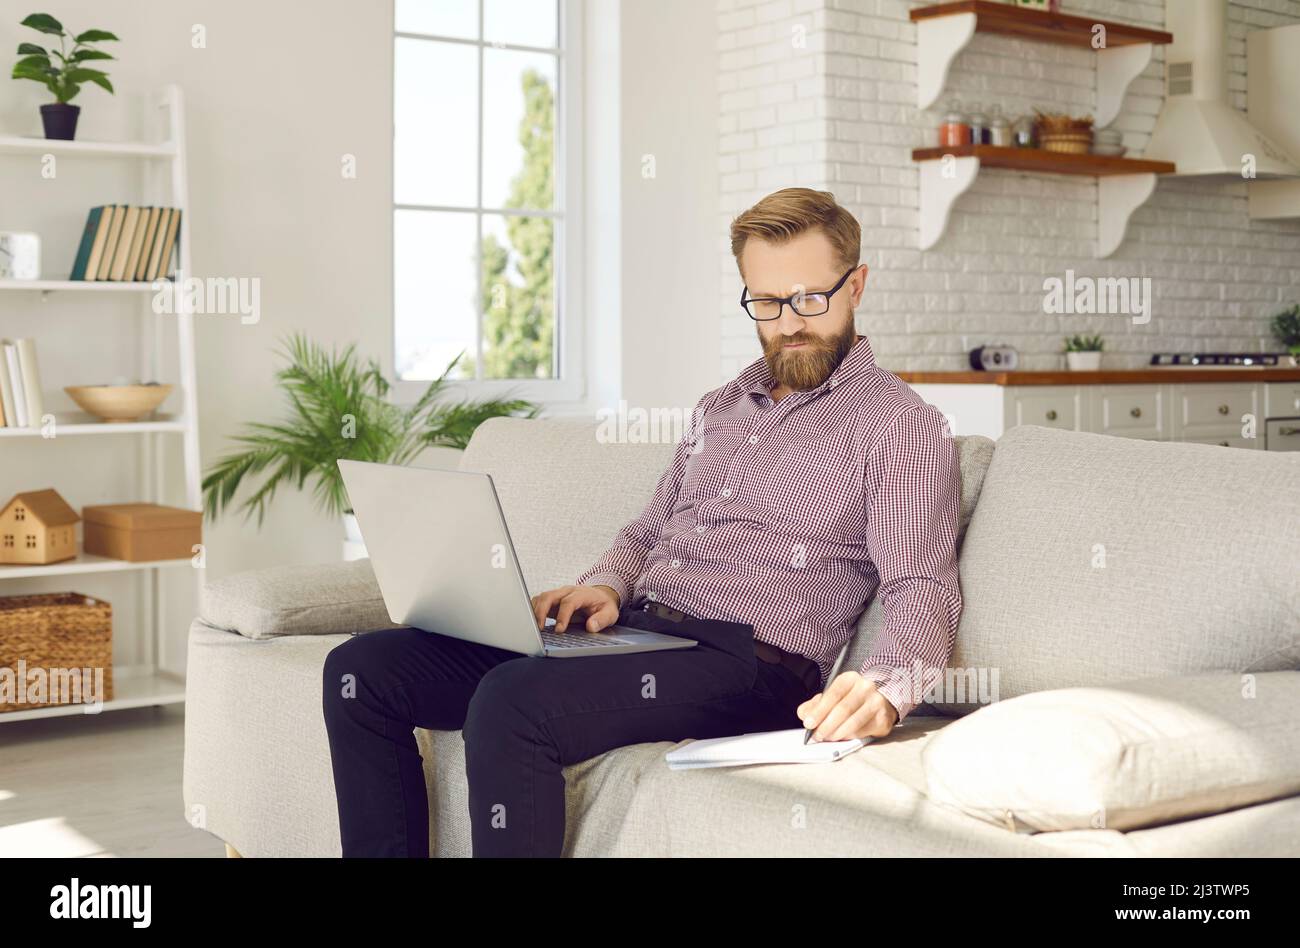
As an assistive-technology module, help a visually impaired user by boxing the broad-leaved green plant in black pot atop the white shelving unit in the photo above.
[13,13,117,142]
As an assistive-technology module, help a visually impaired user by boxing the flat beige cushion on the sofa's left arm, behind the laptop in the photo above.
[199,559,400,639]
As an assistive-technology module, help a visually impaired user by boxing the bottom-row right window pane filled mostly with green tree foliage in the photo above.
[482,215,555,378]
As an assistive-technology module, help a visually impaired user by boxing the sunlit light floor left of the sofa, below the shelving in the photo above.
[0,705,226,858]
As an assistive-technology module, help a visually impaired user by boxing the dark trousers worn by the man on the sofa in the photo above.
[322,607,816,857]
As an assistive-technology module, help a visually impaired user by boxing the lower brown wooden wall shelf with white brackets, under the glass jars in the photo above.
[911,144,1177,257]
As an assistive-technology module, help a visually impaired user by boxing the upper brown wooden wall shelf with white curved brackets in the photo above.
[909,0,1174,129]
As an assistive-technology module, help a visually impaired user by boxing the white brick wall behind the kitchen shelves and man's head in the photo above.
[718,0,1300,378]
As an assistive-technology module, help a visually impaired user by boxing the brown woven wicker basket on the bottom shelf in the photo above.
[0,593,113,714]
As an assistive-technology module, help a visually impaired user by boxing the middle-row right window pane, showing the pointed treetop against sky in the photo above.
[484,48,555,211]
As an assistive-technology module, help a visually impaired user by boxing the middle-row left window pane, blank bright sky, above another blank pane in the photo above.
[393,36,478,207]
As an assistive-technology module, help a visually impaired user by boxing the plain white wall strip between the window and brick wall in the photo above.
[616,0,727,414]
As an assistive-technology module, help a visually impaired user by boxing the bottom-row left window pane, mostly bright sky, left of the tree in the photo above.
[393,211,477,380]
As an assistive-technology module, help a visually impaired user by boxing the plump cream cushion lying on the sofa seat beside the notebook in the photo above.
[920,671,1300,832]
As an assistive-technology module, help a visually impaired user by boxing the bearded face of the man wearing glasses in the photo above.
[741,230,867,391]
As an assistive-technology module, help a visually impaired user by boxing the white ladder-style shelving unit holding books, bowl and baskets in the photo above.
[0,85,203,724]
